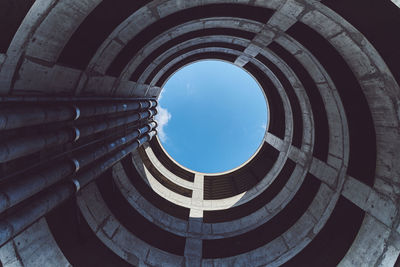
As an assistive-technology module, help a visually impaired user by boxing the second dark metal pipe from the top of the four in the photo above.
[0,109,156,163]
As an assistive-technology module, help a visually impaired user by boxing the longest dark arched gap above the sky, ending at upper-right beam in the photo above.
[107,4,273,76]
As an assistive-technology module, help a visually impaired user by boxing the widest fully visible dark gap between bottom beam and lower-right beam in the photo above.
[203,174,321,259]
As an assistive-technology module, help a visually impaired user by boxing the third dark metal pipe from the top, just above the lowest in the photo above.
[0,122,157,213]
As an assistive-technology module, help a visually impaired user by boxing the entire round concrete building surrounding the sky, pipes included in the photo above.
[0,0,400,267]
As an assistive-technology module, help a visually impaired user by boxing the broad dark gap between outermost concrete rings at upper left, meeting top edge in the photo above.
[57,0,149,69]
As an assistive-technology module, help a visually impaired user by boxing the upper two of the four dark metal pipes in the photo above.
[0,100,157,163]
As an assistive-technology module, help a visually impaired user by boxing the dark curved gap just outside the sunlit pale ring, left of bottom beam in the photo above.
[121,156,190,221]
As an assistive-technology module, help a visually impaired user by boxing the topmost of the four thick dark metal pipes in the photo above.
[0,100,157,130]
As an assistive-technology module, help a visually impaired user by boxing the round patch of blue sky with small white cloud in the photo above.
[156,60,268,173]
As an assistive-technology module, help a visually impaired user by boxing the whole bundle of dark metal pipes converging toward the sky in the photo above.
[0,96,157,246]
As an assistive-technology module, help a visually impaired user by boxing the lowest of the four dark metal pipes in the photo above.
[0,131,156,247]
